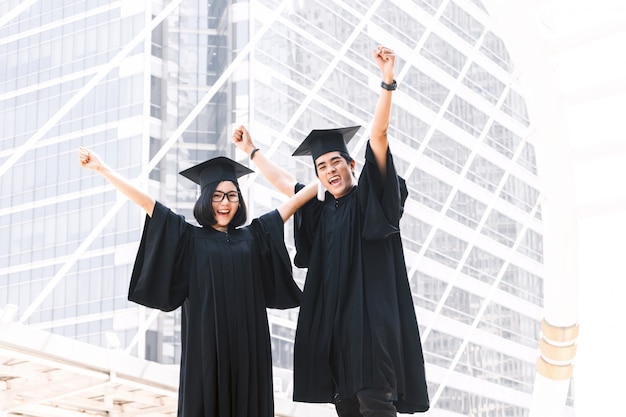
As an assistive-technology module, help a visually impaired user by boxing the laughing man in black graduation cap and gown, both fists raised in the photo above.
[233,47,429,417]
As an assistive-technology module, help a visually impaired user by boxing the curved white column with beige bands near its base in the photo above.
[484,0,579,417]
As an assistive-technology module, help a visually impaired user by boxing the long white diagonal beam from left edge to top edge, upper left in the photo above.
[0,0,182,177]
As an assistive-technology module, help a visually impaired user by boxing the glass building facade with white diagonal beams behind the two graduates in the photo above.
[0,0,572,417]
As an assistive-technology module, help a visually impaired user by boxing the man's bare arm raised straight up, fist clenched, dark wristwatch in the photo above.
[370,45,396,177]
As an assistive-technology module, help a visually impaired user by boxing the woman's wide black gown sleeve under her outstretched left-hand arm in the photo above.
[128,201,193,311]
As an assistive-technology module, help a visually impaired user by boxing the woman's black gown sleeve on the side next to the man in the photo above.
[250,210,302,309]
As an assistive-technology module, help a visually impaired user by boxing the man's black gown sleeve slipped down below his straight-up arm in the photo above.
[359,142,409,240]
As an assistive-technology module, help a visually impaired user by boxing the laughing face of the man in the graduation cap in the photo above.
[315,151,356,198]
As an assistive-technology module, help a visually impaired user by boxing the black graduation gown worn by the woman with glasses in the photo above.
[128,202,301,417]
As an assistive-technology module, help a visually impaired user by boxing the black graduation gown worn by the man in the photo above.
[294,143,429,413]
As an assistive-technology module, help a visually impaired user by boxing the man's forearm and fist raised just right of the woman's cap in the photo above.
[233,126,296,197]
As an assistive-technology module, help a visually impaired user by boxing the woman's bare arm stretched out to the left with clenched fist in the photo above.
[78,147,156,217]
